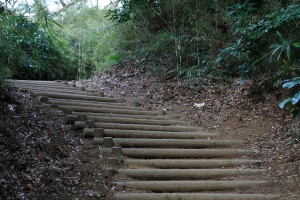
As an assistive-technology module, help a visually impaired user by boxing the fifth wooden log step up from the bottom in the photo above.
[118,148,253,158]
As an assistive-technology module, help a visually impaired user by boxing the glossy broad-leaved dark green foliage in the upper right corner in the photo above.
[218,4,300,81]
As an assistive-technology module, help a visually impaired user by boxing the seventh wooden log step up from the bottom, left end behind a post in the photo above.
[83,128,218,139]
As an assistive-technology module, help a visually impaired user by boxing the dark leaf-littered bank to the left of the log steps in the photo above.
[0,89,111,200]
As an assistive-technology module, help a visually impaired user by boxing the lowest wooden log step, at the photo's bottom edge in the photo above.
[114,193,280,200]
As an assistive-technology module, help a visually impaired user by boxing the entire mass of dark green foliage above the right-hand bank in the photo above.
[107,0,300,123]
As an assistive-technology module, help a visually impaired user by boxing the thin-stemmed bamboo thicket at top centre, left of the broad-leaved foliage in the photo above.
[107,0,234,78]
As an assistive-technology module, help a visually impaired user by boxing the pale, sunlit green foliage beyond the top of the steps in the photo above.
[56,3,122,78]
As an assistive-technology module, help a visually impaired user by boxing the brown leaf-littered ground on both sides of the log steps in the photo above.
[0,63,300,200]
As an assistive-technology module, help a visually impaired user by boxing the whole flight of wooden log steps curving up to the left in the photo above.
[14,81,281,200]
